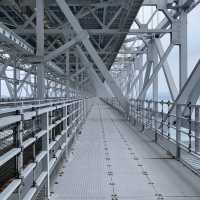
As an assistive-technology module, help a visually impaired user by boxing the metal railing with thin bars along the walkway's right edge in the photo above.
[103,98,200,174]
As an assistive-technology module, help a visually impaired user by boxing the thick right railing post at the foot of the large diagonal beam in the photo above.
[176,104,181,160]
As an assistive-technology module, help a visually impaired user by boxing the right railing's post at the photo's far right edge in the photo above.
[195,106,200,153]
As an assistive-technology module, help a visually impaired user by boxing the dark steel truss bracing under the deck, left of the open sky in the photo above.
[0,0,142,104]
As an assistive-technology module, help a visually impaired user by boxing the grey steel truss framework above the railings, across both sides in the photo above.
[0,0,199,145]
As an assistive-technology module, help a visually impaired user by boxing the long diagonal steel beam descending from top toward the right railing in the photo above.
[56,0,128,110]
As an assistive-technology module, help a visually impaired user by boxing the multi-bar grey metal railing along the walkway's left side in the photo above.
[0,98,93,200]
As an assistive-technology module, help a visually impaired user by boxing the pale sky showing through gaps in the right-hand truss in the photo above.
[120,5,200,100]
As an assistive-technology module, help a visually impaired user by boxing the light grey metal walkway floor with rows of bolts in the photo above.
[51,101,200,200]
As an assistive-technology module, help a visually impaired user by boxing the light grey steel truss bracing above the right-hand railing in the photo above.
[112,0,200,104]
